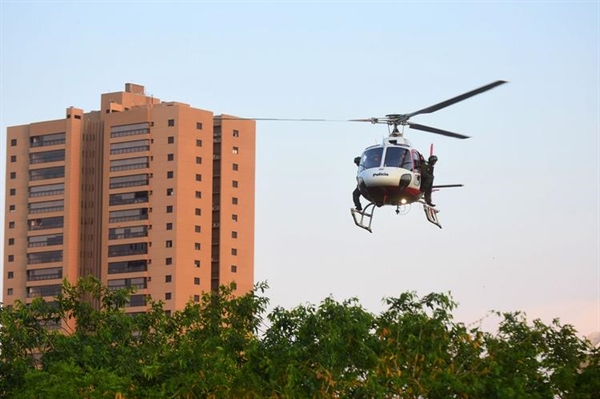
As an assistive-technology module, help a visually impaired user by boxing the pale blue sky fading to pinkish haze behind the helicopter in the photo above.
[0,0,600,335]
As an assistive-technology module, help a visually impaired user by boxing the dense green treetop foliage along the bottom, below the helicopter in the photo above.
[0,277,600,399]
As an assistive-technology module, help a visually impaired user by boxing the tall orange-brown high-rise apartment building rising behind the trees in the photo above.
[3,83,255,312]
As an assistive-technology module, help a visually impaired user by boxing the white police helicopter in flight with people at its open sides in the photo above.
[218,80,507,233]
